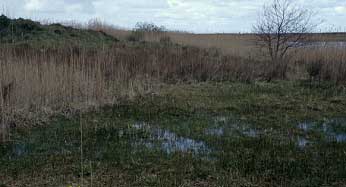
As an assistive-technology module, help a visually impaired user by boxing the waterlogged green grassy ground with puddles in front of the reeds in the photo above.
[0,82,346,186]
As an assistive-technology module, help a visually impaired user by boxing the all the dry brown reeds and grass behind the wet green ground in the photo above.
[0,21,346,142]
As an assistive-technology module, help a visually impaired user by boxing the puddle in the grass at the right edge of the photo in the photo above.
[298,118,346,146]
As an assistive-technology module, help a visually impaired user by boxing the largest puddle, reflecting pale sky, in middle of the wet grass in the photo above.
[133,123,210,154]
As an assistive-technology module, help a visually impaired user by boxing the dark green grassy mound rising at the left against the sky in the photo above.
[0,15,118,48]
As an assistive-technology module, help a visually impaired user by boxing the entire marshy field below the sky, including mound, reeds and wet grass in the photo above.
[0,17,346,187]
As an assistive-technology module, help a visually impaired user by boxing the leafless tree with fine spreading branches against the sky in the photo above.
[253,0,314,79]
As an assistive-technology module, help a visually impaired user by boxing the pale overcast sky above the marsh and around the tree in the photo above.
[0,0,346,33]
